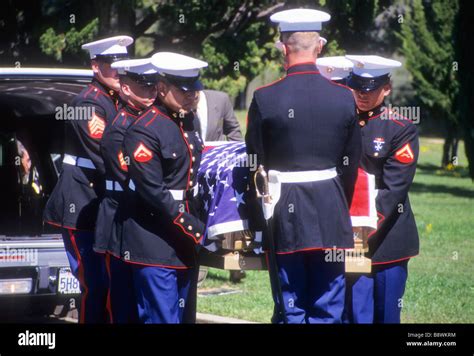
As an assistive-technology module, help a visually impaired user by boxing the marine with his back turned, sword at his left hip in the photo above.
[246,9,361,323]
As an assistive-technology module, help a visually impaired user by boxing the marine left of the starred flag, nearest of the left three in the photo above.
[121,52,207,323]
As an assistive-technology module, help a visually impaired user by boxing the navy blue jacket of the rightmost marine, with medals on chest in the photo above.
[359,104,419,264]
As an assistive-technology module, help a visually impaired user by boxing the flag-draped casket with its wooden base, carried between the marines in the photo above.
[198,142,377,273]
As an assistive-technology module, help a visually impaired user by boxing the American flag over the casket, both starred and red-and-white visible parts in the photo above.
[198,142,377,253]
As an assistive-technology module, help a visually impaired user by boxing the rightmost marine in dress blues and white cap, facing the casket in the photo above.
[346,56,419,323]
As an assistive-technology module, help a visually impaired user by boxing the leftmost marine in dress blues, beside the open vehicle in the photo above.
[44,36,133,323]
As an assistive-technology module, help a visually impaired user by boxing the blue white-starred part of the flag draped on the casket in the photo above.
[198,142,250,250]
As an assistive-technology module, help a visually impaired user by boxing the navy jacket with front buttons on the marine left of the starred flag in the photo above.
[119,105,205,269]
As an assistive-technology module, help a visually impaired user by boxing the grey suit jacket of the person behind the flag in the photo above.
[202,90,243,141]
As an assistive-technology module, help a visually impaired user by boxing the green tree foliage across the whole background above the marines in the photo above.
[0,0,474,176]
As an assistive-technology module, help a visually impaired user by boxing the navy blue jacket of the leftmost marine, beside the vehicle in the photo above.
[44,80,119,231]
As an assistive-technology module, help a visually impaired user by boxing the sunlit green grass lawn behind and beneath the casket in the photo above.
[198,112,474,323]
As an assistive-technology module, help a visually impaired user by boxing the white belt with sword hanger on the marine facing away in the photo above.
[262,167,337,220]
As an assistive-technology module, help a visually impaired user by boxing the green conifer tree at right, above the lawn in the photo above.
[401,0,459,166]
